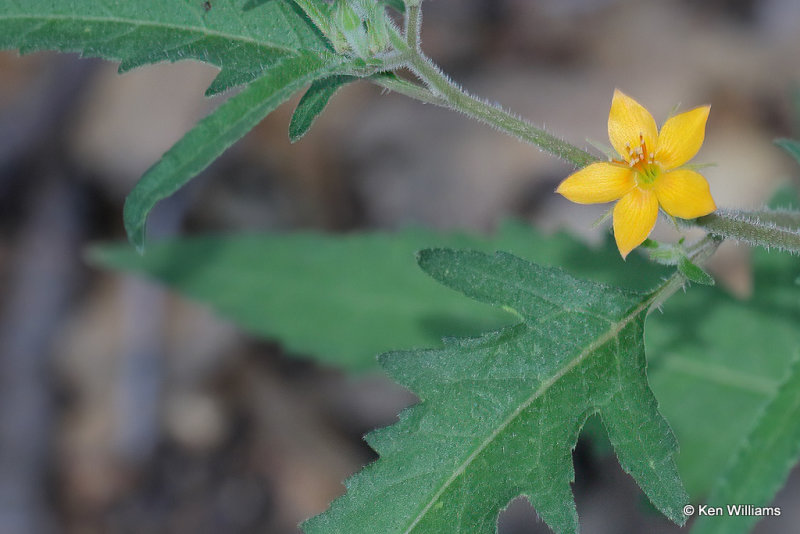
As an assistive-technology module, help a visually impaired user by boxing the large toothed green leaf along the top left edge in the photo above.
[0,0,333,93]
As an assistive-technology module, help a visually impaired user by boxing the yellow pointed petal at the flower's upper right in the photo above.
[656,106,711,169]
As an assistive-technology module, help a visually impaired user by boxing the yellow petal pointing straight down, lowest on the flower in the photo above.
[614,187,658,259]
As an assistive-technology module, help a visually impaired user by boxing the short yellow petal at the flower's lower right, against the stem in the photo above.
[653,169,717,219]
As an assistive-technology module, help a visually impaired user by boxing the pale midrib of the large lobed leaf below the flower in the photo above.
[404,295,654,534]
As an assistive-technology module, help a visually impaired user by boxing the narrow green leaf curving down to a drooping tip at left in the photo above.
[123,54,350,250]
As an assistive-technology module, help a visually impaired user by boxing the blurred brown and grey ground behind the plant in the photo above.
[0,0,800,534]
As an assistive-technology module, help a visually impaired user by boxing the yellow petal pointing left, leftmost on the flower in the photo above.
[556,162,636,204]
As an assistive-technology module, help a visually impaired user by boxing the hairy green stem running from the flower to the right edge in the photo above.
[690,210,800,254]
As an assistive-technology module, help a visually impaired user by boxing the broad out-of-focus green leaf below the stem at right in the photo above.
[646,192,800,502]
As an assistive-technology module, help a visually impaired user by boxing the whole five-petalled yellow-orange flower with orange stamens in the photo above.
[556,90,717,258]
